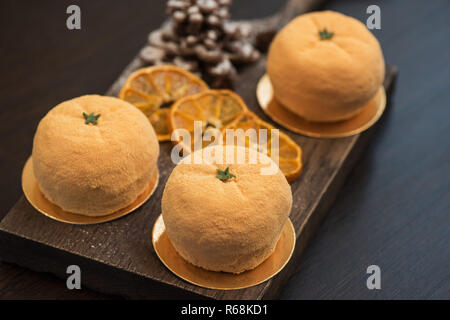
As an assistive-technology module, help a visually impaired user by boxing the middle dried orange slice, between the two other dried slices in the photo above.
[169,90,248,153]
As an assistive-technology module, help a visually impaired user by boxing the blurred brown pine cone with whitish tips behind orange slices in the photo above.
[140,0,260,87]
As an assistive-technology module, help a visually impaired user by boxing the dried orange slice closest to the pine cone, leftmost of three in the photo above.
[119,65,208,141]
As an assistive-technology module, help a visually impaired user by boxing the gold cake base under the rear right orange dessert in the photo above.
[256,74,386,138]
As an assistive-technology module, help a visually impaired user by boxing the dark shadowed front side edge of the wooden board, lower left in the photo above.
[0,228,208,300]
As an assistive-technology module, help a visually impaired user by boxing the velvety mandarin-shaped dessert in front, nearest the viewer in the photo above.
[162,146,292,273]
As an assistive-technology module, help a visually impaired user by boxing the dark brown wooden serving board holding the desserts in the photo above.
[0,1,396,299]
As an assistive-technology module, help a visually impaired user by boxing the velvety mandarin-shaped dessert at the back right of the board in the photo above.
[267,11,385,122]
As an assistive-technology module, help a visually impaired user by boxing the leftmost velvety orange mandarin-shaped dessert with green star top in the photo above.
[32,95,159,216]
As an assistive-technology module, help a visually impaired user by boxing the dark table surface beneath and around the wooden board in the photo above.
[0,0,450,299]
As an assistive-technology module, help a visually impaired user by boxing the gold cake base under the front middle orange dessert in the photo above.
[152,215,295,290]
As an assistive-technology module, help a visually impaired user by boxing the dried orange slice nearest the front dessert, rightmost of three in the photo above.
[223,111,302,182]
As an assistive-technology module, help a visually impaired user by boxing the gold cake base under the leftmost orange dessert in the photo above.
[22,157,159,224]
